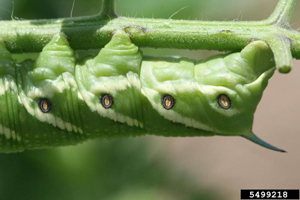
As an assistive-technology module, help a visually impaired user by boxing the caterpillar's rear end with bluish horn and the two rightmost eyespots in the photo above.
[143,41,282,151]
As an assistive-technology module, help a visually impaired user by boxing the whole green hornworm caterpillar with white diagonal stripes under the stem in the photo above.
[0,31,283,152]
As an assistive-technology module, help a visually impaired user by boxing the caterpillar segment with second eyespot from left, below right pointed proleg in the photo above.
[76,30,144,131]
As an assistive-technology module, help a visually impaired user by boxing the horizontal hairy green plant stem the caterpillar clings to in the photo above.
[0,0,300,59]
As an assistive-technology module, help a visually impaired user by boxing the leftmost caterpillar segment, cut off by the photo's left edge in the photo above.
[0,41,24,152]
